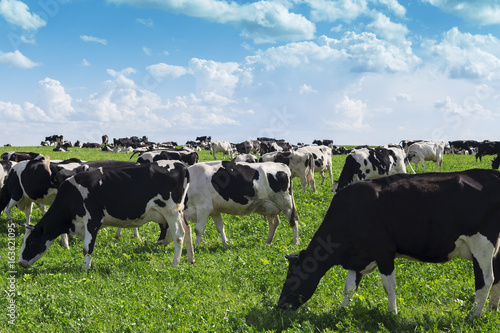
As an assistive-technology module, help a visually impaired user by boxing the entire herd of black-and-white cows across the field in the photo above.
[0,137,500,316]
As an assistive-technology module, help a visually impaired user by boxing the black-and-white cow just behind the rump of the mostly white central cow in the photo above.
[259,150,316,193]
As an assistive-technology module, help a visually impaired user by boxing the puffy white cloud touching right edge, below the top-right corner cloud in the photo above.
[429,28,500,80]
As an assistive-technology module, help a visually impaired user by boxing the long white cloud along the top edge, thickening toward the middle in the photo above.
[108,0,316,43]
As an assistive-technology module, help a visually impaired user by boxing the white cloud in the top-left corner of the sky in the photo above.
[0,0,47,30]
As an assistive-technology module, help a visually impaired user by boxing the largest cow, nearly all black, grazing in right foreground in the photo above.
[278,169,500,316]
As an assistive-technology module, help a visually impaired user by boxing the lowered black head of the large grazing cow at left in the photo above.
[18,223,53,268]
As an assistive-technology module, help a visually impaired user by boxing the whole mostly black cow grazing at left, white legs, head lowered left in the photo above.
[18,163,194,271]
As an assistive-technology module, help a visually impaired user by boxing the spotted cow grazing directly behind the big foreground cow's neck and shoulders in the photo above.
[333,146,406,195]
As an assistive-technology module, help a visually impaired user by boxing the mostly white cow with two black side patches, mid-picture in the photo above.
[178,161,299,246]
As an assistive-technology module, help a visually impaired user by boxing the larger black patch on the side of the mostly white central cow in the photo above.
[211,161,259,205]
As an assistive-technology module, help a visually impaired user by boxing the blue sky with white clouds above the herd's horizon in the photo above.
[0,0,500,146]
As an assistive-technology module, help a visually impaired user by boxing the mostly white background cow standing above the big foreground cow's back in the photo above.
[406,141,446,173]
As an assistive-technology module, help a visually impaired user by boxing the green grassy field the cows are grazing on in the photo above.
[0,147,500,332]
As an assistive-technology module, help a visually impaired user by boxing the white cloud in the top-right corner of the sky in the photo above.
[424,0,500,25]
